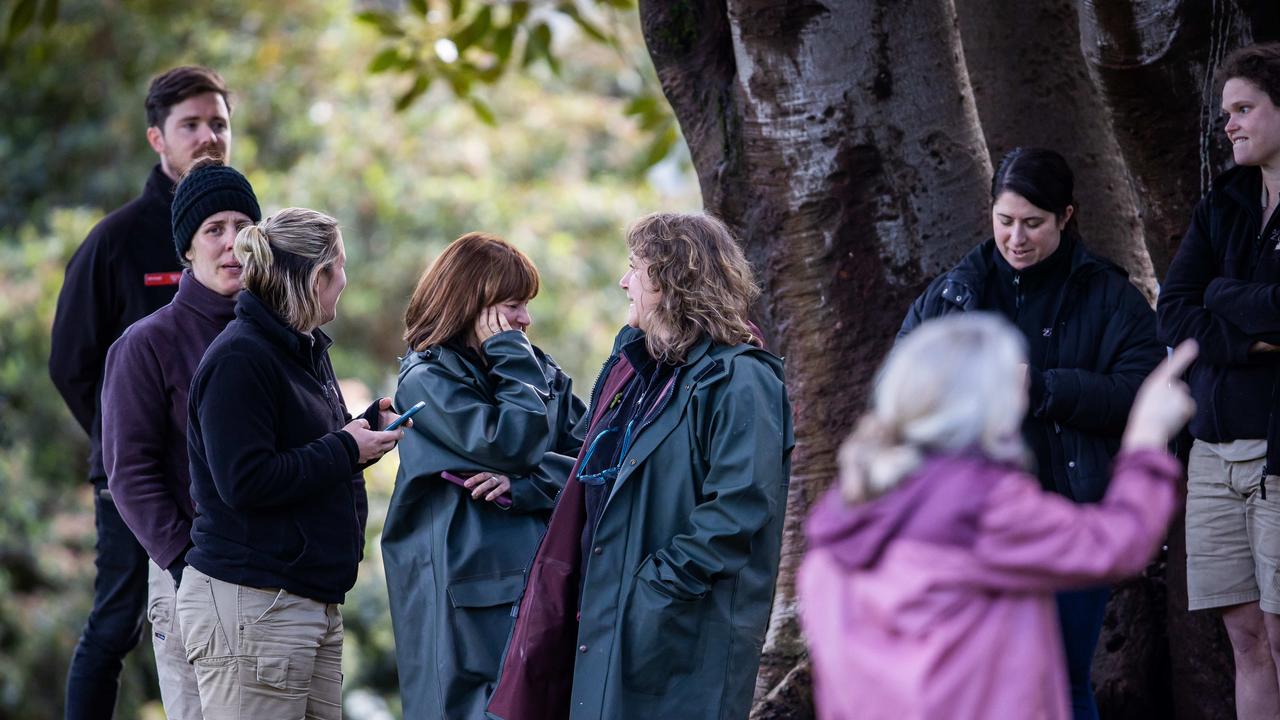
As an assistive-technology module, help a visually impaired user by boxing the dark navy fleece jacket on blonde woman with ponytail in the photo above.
[187,290,376,602]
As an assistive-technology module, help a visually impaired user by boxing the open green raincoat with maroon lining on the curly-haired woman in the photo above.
[488,329,795,720]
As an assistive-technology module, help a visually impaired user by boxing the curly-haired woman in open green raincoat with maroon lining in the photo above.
[489,214,794,720]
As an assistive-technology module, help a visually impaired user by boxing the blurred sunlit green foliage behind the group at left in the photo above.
[0,0,700,720]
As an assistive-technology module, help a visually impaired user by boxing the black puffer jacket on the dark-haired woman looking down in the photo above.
[899,240,1165,502]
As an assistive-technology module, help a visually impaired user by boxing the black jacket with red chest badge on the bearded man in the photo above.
[49,165,182,479]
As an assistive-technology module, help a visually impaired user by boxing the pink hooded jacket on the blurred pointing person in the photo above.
[797,451,1181,720]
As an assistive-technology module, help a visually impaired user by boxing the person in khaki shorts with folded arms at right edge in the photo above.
[1156,44,1280,719]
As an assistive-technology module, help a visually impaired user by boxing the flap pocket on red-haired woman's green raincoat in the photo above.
[448,571,525,680]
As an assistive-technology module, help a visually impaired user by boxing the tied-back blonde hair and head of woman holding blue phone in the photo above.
[232,208,342,333]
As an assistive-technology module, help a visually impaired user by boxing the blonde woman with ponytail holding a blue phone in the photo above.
[178,208,403,720]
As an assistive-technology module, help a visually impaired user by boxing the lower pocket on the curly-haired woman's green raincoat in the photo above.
[621,561,707,694]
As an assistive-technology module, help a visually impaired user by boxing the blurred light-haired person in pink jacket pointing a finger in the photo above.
[799,313,1196,720]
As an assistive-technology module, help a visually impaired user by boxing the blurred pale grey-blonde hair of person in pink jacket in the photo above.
[840,313,1027,502]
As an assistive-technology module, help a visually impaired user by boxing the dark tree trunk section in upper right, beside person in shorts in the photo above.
[1079,0,1280,279]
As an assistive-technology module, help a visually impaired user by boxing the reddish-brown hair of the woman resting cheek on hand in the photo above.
[404,232,539,352]
